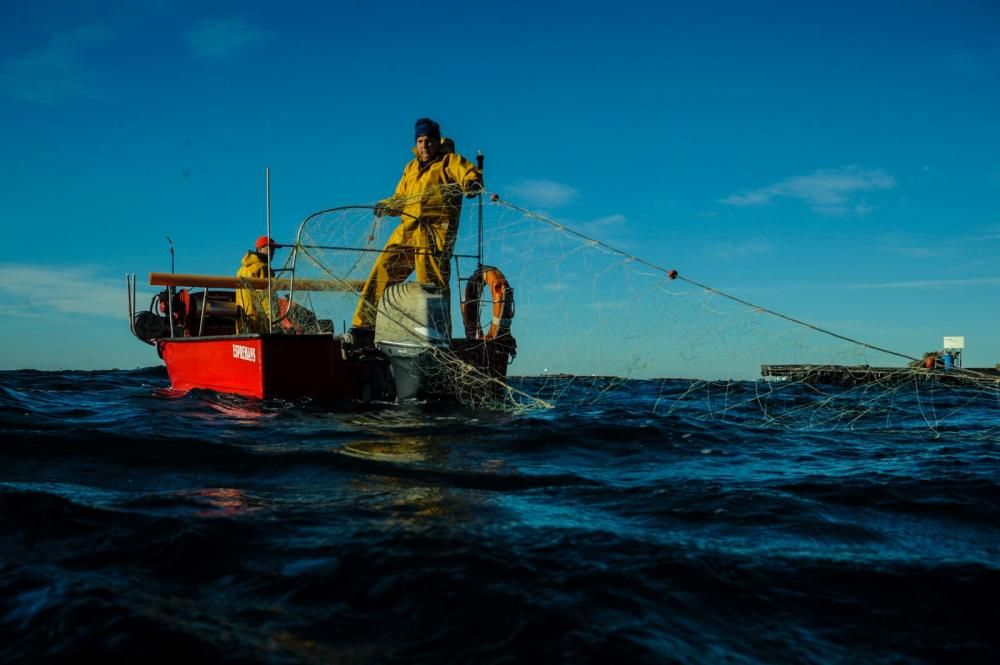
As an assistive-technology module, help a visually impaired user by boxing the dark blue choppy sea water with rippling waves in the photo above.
[0,368,1000,663]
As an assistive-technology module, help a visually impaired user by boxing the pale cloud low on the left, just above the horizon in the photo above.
[0,263,143,321]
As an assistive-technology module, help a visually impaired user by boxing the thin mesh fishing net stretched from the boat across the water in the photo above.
[240,187,1000,437]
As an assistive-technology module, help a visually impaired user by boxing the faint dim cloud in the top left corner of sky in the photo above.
[0,25,110,104]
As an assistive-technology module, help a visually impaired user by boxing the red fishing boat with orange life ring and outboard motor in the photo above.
[127,206,516,402]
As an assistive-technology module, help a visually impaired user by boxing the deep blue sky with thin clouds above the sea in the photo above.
[0,0,1000,369]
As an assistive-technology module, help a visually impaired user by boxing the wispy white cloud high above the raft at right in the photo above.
[722,166,896,215]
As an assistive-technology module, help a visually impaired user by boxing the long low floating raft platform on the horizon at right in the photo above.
[760,365,1000,386]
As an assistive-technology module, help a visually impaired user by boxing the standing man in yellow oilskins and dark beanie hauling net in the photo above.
[351,118,483,345]
